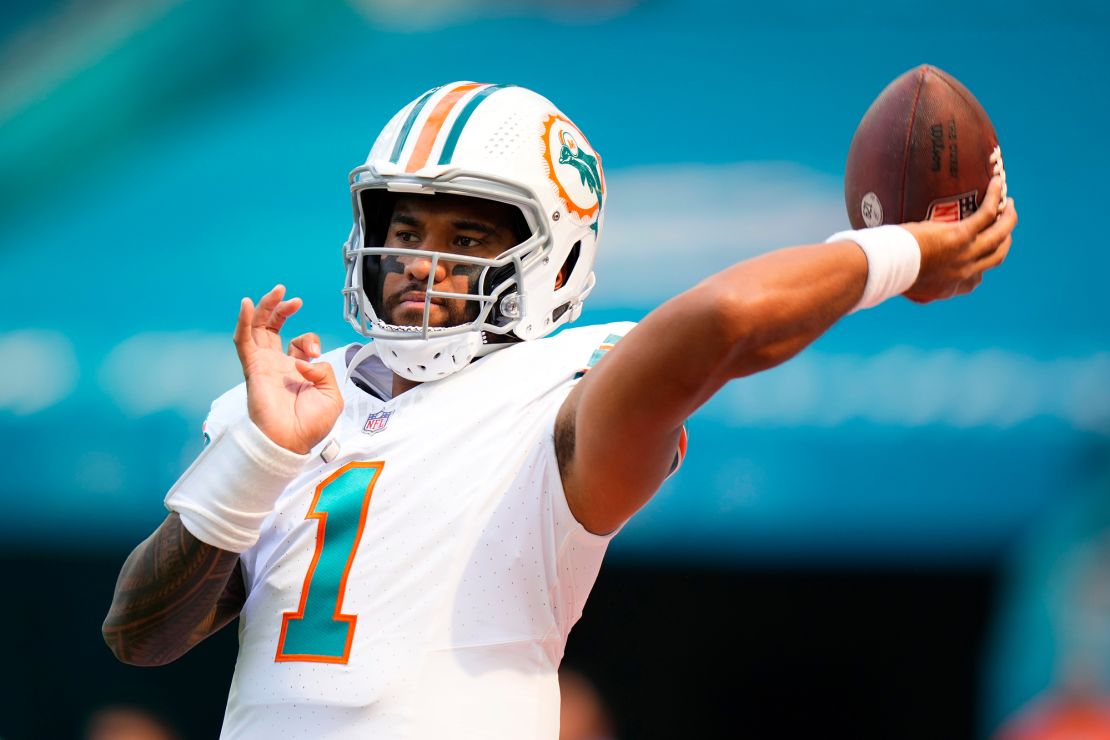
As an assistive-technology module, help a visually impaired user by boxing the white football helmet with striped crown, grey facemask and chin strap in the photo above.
[343,82,606,382]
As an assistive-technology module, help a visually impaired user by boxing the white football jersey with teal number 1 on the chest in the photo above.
[195,324,632,740]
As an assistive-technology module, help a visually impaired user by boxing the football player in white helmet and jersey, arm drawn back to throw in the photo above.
[104,82,1017,740]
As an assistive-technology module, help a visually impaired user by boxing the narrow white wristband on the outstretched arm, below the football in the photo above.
[825,226,921,312]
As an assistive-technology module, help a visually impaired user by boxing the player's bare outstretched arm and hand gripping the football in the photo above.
[555,178,1017,534]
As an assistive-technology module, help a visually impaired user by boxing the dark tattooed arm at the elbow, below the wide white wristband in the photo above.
[103,514,245,666]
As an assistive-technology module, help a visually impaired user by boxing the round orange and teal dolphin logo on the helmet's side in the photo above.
[544,115,605,232]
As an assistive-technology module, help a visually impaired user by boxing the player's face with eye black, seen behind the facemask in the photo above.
[381,194,519,326]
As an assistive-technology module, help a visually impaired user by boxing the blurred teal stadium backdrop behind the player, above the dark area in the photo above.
[0,0,1110,727]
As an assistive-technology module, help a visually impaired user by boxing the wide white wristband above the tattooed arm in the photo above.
[165,418,312,553]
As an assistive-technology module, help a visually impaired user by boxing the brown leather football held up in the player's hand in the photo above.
[844,64,1002,229]
